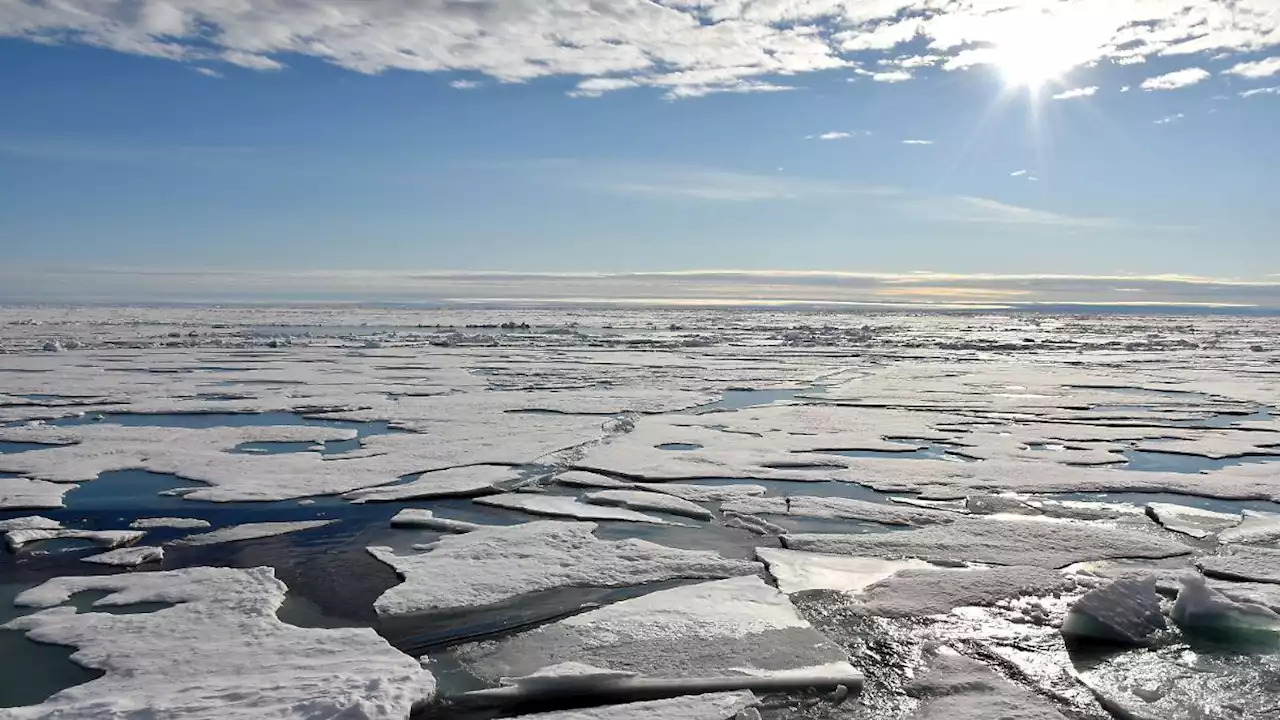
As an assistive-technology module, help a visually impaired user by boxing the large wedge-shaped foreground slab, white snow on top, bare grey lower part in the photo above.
[454,575,858,680]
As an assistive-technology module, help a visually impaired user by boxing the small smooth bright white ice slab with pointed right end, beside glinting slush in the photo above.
[755,547,934,594]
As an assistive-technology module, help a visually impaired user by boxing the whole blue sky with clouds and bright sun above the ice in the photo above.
[0,0,1280,306]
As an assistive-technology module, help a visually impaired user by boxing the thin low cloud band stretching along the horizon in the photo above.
[0,265,1280,309]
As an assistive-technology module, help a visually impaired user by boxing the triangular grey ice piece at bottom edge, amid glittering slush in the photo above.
[906,648,1066,720]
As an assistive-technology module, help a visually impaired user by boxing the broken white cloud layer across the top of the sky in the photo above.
[0,0,1280,99]
